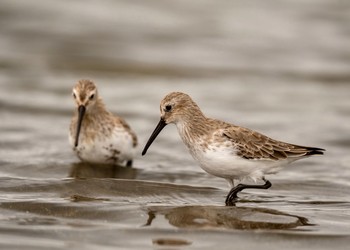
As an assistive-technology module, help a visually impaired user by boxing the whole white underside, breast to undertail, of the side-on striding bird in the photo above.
[176,119,288,181]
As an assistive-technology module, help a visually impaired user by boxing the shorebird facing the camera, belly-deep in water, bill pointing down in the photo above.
[69,80,137,166]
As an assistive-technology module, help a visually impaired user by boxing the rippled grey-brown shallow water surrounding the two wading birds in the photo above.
[0,0,350,249]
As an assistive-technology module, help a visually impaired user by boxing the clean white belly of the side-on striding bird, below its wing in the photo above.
[191,147,287,181]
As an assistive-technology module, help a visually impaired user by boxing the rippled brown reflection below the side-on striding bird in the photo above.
[144,206,312,230]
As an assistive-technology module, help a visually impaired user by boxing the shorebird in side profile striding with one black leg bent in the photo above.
[142,92,324,205]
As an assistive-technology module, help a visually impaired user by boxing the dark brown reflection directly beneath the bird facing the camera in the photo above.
[69,162,138,179]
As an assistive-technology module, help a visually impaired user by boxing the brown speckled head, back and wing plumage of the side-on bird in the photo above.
[160,92,323,160]
